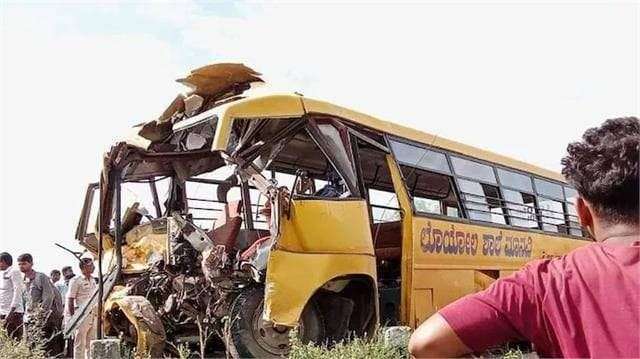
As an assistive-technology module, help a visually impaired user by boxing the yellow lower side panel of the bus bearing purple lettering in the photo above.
[409,216,589,327]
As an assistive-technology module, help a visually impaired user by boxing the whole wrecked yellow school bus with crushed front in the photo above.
[68,64,588,357]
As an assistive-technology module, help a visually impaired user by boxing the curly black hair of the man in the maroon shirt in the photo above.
[562,117,640,224]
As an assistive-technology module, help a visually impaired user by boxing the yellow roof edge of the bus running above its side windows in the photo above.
[214,94,565,182]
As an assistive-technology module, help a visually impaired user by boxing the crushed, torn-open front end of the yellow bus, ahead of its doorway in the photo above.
[67,64,378,357]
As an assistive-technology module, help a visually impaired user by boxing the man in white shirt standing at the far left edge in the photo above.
[0,252,24,339]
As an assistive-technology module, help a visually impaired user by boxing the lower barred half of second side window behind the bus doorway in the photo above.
[458,179,506,224]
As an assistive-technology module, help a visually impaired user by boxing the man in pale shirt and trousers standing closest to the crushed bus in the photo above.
[66,258,97,359]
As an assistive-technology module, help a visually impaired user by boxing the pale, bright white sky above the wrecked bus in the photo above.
[0,1,640,272]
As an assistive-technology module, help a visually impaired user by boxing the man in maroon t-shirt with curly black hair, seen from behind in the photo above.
[409,118,640,358]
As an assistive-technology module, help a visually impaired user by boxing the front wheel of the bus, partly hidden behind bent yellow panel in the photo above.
[229,287,324,358]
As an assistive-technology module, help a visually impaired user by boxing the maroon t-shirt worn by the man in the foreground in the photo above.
[439,241,640,358]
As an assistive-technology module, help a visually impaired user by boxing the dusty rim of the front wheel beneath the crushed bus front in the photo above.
[251,303,302,356]
